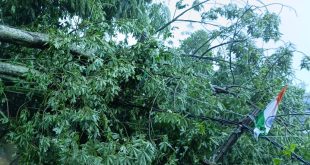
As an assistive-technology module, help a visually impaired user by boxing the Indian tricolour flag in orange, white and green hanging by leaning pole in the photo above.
[254,86,287,139]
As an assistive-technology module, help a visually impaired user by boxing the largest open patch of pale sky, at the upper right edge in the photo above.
[275,0,310,92]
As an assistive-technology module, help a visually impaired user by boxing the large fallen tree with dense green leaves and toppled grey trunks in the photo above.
[0,0,310,164]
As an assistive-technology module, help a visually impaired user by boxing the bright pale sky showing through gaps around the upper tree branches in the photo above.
[167,0,310,92]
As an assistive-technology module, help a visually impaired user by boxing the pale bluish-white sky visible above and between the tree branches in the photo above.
[165,0,310,93]
